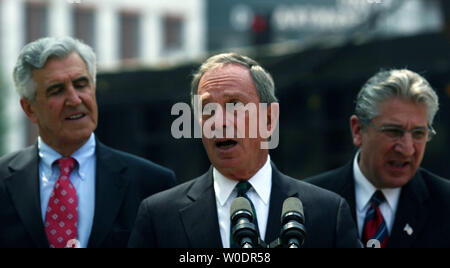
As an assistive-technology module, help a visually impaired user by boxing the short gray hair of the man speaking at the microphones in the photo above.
[191,53,278,107]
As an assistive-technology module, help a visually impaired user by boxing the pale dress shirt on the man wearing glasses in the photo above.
[353,152,401,237]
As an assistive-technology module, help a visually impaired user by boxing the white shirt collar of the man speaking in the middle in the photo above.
[213,155,272,206]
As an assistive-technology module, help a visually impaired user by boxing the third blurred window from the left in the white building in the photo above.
[120,12,139,59]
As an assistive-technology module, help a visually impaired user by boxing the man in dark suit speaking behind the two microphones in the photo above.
[129,53,360,248]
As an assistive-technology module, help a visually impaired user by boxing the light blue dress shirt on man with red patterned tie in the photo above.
[38,133,96,248]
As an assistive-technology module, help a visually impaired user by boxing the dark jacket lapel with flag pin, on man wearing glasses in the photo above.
[388,171,430,248]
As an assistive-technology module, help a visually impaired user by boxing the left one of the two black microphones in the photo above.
[230,197,258,248]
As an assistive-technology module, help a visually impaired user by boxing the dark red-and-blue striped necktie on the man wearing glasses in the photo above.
[362,190,389,248]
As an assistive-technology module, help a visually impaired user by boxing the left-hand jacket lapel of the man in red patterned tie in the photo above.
[6,145,49,248]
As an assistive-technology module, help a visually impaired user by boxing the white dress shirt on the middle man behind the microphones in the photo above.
[213,156,272,248]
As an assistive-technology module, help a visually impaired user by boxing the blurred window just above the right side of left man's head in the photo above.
[73,7,95,48]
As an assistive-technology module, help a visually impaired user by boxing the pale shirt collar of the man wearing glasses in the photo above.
[353,151,401,212]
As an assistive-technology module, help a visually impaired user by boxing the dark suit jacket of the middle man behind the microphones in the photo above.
[129,164,360,248]
